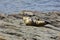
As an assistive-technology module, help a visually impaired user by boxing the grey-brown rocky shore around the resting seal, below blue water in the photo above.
[0,10,60,40]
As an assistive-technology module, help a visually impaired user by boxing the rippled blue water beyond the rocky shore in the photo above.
[0,0,60,13]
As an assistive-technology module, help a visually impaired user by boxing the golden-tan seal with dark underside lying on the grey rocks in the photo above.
[23,17,48,26]
